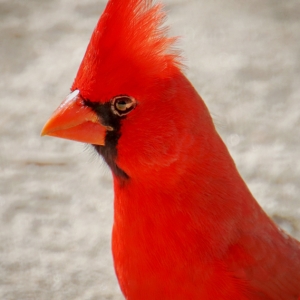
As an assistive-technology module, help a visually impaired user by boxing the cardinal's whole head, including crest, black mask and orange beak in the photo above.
[42,0,213,179]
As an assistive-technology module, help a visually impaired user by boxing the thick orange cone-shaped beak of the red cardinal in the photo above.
[41,90,112,145]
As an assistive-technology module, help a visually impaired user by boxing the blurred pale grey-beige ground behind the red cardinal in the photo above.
[0,0,300,300]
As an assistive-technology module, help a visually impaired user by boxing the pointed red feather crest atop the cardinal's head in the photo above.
[72,0,180,102]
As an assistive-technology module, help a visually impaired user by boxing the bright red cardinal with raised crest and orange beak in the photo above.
[42,0,300,300]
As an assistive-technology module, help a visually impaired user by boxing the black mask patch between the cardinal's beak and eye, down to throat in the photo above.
[84,100,129,180]
